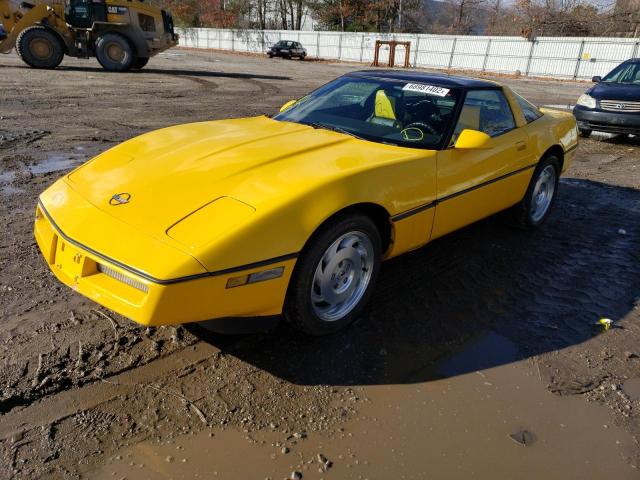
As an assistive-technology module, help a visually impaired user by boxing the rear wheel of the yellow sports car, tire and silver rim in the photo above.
[512,155,560,229]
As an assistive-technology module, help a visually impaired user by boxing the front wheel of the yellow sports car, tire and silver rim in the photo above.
[284,215,382,335]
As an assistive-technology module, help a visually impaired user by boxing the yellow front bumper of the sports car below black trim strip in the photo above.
[34,205,295,326]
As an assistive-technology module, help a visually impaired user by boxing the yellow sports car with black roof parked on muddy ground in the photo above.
[35,70,578,335]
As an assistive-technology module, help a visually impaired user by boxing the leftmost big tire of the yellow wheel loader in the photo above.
[16,25,64,69]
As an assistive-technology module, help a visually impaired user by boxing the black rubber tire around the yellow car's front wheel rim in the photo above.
[284,214,382,336]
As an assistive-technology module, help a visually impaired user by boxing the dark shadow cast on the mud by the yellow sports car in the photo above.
[182,179,640,385]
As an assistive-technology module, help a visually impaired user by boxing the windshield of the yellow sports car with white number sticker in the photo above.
[274,76,460,149]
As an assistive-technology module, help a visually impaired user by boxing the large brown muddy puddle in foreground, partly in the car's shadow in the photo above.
[90,333,638,480]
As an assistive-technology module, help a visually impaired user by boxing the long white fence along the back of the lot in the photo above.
[179,28,640,79]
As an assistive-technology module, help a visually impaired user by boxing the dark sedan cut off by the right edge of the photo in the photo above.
[573,58,640,137]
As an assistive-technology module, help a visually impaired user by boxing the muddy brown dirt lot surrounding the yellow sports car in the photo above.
[0,50,640,479]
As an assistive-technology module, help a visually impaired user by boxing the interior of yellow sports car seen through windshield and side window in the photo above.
[282,80,516,148]
